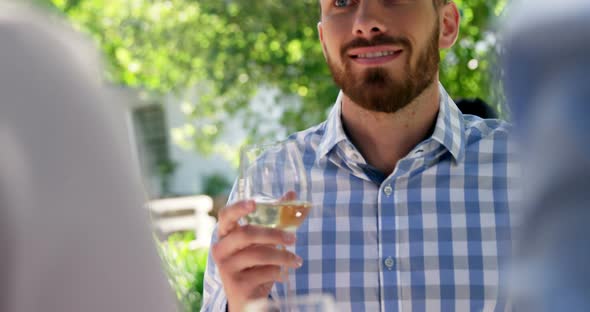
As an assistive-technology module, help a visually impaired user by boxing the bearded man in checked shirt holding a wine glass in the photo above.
[203,0,514,311]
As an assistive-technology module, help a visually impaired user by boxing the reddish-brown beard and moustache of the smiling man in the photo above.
[327,21,440,113]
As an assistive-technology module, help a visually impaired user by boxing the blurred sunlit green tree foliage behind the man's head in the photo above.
[51,0,507,158]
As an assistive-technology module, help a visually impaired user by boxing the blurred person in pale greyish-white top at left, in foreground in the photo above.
[0,1,176,312]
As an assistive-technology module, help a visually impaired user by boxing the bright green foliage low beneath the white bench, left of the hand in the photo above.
[160,232,208,312]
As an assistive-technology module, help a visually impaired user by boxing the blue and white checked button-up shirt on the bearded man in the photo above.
[202,86,519,311]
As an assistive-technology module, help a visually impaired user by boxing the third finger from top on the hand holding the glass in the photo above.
[223,246,303,272]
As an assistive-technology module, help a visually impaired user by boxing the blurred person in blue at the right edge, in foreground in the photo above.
[503,0,590,312]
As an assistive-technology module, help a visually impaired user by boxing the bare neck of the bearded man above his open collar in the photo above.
[342,79,440,175]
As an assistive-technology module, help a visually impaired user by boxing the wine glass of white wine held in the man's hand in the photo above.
[237,141,312,299]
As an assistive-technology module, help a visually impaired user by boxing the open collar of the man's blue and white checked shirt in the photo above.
[316,83,465,161]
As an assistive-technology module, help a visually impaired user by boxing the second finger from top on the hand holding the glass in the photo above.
[212,225,297,260]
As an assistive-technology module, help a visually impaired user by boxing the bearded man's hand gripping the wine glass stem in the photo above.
[211,201,302,312]
